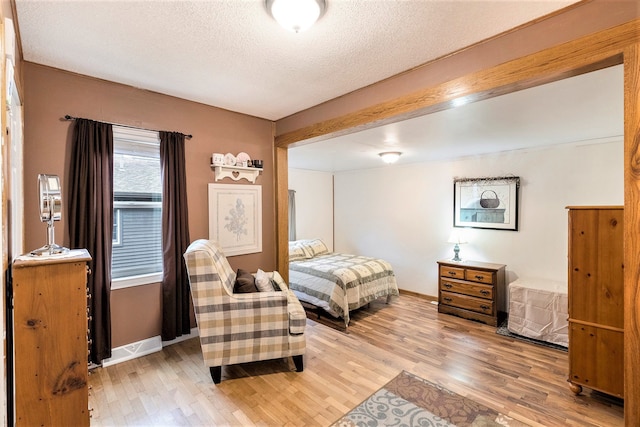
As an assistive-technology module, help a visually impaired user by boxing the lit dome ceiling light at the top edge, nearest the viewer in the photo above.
[266,0,326,33]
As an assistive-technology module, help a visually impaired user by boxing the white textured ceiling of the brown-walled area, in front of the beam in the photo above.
[15,0,576,120]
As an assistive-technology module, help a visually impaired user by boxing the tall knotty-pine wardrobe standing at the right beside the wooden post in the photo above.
[567,206,624,397]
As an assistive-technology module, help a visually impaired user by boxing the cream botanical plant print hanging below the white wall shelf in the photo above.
[209,184,262,256]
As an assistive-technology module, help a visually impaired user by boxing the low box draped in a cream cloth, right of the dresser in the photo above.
[508,278,569,347]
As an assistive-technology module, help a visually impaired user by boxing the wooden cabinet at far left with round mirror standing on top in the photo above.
[13,250,91,426]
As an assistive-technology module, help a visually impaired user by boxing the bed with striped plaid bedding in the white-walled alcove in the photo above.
[289,239,399,327]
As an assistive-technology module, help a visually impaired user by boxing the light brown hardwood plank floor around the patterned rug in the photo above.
[90,294,624,427]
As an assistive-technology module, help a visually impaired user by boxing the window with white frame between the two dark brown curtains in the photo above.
[111,126,162,287]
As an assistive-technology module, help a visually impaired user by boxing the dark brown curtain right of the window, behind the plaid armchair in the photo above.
[160,131,191,341]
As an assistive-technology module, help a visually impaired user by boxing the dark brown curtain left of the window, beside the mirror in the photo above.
[68,119,113,364]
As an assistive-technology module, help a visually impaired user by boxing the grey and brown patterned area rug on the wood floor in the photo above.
[332,371,528,427]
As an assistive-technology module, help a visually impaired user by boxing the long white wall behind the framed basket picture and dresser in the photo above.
[334,139,624,296]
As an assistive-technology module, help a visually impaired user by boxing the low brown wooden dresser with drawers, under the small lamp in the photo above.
[438,261,505,326]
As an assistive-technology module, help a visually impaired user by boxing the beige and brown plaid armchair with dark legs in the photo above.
[184,239,307,384]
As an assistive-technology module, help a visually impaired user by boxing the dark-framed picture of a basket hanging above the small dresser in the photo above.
[453,176,520,231]
